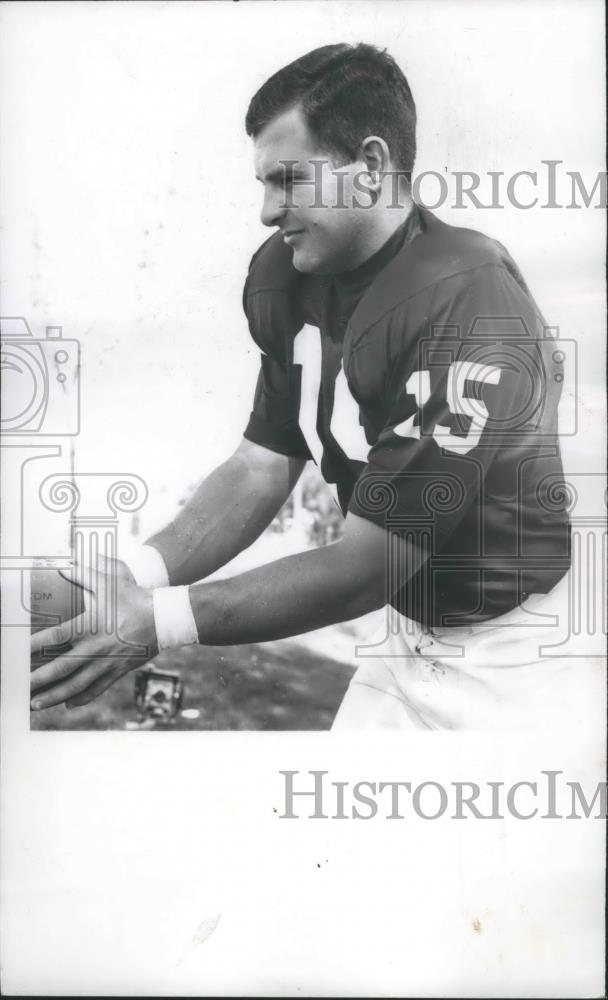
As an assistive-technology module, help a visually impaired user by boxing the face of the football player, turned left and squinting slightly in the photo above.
[254,108,374,274]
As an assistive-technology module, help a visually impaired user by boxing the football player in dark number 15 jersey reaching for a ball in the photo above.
[32,44,595,729]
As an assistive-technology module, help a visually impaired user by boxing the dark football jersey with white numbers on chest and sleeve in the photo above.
[244,207,570,625]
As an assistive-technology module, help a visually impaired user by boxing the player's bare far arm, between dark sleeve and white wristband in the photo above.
[146,438,306,586]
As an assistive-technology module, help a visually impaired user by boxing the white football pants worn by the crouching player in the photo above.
[332,573,606,734]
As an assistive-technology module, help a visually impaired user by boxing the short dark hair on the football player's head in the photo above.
[245,43,416,172]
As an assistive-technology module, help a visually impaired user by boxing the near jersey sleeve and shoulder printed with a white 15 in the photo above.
[349,264,560,551]
